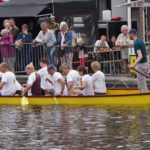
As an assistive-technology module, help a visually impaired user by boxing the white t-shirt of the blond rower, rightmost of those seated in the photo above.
[92,71,107,93]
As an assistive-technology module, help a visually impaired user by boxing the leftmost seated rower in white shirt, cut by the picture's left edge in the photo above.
[0,62,16,96]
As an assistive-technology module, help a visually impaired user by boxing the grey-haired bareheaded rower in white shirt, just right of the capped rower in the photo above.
[61,64,81,95]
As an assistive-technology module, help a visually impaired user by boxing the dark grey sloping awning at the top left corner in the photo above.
[0,0,51,18]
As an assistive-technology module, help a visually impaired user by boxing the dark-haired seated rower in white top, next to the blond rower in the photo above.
[78,67,94,96]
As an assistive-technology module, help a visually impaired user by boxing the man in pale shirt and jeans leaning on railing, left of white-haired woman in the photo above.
[34,22,56,64]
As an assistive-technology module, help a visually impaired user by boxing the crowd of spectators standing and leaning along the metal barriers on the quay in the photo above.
[0,17,137,72]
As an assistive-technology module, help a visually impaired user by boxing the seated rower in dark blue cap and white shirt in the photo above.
[47,65,68,96]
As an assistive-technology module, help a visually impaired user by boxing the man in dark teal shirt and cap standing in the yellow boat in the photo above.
[129,29,148,93]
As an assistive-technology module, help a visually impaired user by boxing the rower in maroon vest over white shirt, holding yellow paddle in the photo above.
[22,63,42,96]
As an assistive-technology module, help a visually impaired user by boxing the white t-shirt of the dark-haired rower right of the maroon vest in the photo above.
[37,67,52,90]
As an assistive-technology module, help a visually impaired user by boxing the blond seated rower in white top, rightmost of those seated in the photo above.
[91,61,107,95]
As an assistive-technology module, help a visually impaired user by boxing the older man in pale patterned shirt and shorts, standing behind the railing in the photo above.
[116,25,130,73]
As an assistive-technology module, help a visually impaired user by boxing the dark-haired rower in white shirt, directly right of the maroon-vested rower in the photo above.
[37,58,52,95]
